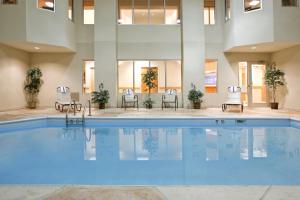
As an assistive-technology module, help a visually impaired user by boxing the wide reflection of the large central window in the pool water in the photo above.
[119,128,182,160]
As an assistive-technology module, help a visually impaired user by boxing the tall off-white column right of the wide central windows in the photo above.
[181,0,205,107]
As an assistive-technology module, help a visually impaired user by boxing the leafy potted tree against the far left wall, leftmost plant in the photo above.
[24,67,43,109]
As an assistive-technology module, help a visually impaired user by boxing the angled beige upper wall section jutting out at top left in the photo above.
[26,0,76,51]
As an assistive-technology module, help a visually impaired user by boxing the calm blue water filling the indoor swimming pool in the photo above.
[0,119,300,185]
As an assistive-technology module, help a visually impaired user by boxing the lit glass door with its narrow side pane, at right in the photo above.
[239,62,268,107]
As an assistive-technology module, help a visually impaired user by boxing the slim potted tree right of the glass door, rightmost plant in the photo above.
[265,64,284,110]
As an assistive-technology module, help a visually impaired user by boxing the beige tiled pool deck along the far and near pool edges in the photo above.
[0,108,300,200]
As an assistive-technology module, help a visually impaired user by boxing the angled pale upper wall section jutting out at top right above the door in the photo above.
[224,0,274,50]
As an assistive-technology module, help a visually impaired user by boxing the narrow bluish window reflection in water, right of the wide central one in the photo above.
[205,129,219,161]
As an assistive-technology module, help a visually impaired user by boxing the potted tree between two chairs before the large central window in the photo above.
[142,68,158,109]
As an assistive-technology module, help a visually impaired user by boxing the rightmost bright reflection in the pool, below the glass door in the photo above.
[253,128,268,158]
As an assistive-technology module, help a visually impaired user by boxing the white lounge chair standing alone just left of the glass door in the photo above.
[222,86,244,112]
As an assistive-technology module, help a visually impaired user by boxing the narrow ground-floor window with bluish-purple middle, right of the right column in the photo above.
[204,60,218,93]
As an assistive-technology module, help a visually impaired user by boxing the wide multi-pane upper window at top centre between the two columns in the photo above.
[118,0,180,24]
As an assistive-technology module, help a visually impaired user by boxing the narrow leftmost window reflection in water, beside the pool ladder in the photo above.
[84,128,96,160]
